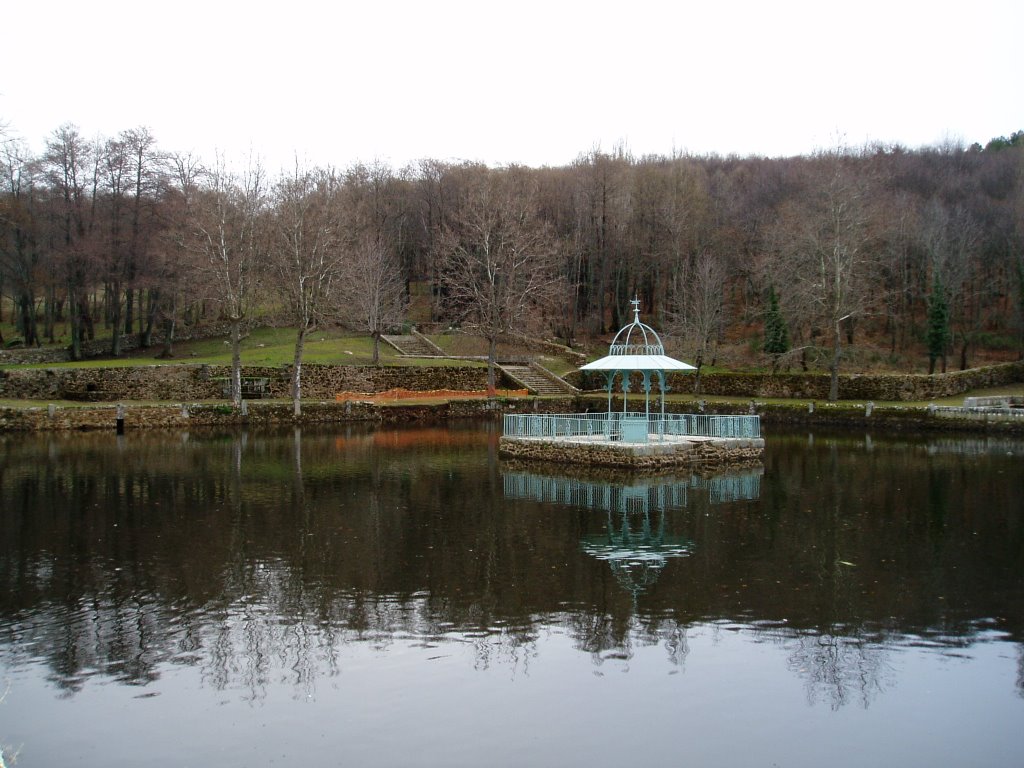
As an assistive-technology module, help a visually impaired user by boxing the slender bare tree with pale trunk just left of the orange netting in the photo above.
[273,165,342,416]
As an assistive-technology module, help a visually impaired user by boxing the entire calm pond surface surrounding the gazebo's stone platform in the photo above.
[0,424,1024,768]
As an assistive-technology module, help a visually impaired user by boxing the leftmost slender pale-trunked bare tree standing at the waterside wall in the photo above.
[193,156,267,407]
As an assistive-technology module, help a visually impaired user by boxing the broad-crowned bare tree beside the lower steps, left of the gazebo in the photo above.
[439,172,564,391]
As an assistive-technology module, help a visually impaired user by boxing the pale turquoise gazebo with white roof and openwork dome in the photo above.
[580,299,696,419]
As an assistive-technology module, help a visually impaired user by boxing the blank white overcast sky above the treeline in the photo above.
[0,0,1024,170]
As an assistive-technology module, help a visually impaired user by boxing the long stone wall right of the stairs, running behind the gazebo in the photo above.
[566,361,1024,401]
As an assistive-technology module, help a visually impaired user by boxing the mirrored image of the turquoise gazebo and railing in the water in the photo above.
[502,466,763,601]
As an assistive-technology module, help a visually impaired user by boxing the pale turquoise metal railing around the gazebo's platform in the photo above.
[504,413,761,442]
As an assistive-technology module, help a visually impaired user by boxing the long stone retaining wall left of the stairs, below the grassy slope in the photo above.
[0,365,495,402]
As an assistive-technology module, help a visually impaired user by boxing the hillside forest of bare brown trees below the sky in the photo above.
[0,120,1024,378]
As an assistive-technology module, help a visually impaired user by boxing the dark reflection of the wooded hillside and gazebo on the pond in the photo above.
[0,424,1024,707]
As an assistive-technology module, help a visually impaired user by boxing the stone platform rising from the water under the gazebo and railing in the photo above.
[499,435,765,469]
